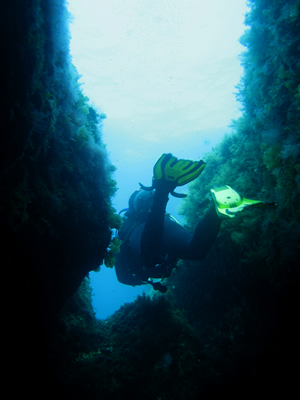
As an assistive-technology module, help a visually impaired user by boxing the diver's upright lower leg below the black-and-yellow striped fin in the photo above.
[140,189,169,268]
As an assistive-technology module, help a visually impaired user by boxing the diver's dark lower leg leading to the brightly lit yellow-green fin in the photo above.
[188,205,221,260]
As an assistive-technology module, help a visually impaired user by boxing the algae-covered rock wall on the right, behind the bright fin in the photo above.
[169,1,300,390]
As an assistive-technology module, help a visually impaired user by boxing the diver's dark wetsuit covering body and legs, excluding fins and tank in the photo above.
[115,190,221,286]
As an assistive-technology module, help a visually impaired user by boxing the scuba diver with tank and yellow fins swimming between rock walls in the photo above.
[115,154,270,293]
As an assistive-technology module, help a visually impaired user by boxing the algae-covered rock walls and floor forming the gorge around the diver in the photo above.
[0,0,300,400]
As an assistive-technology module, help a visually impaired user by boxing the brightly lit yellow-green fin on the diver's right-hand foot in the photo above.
[210,185,275,219]
